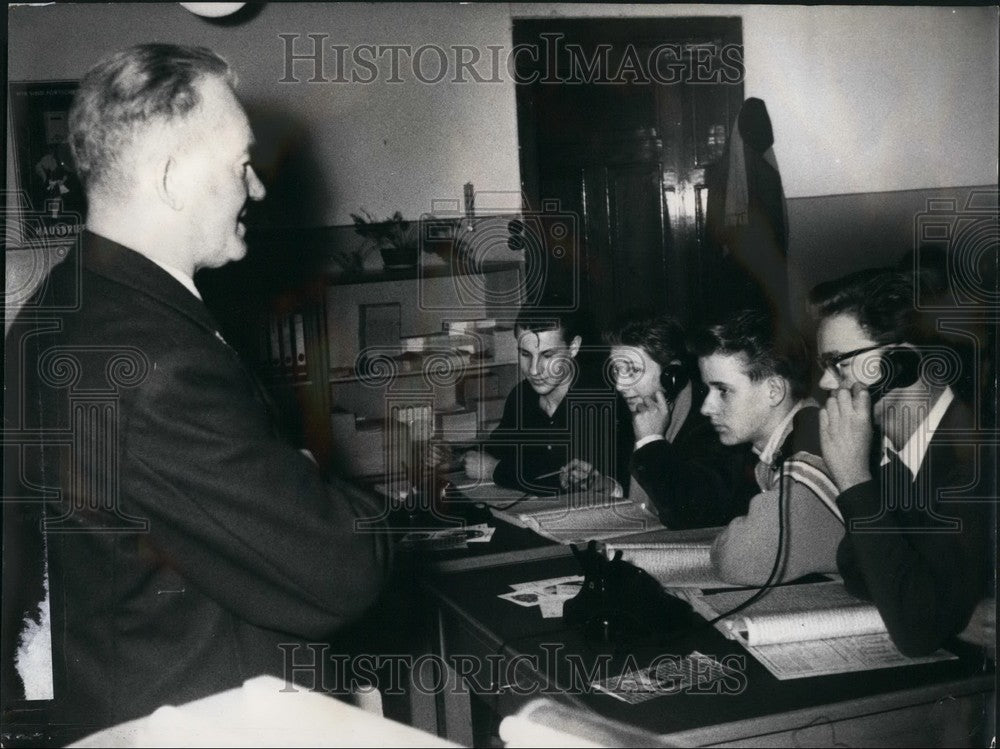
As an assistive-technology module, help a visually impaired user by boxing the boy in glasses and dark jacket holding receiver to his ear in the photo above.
[811,270,996,655]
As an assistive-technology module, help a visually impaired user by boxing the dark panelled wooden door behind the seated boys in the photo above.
[515,18,743,327]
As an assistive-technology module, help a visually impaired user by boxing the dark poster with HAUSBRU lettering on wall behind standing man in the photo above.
[8,81,86,240]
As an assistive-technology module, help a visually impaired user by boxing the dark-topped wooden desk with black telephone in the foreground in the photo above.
[422,557,995,746]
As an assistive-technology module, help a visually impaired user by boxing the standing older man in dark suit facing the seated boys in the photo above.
[3,44,388,741]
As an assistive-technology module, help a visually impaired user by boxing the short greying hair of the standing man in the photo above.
[69,44,236,187]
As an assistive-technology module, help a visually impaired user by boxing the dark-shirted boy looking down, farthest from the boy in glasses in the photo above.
[463,309,632,493]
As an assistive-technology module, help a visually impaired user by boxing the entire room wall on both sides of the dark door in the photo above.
[8,2,998,316]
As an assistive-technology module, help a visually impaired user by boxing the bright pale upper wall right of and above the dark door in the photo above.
[512,4,998,197]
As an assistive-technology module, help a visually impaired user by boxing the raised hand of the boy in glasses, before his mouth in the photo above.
[819,383,872,492]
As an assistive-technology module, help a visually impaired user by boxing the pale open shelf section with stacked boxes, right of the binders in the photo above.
[325,263,523,477]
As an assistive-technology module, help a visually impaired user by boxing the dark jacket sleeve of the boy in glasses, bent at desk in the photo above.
[838,478,989,656]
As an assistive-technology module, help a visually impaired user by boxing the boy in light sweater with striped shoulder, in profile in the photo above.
[695,310,844,585]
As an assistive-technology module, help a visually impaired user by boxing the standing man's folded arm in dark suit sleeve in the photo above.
[121,349,390,638]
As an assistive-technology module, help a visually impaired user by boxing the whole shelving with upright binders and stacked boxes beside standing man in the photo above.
[199,217,539,480]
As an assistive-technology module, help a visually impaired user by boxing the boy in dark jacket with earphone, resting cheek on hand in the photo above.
[604,316,757,529]
